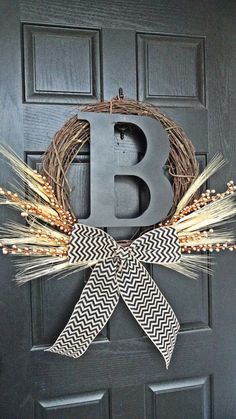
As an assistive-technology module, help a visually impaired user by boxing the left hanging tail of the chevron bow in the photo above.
[46,260,119,358]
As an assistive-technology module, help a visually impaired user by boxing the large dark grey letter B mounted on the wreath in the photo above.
[78,112,173,227]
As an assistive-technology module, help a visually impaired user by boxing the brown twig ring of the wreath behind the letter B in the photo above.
[43,97,199,221]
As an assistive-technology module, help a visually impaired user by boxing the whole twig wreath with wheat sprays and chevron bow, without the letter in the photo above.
[0,97,236,368]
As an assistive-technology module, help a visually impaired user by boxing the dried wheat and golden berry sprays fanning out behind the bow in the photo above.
[0,146,236,284]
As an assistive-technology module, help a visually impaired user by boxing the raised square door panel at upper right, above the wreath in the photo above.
[137,33,205,107]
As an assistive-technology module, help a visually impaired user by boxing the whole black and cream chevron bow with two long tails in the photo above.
[48,224,181,368]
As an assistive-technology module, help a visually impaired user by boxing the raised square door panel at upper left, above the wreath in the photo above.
[23,25,102,103]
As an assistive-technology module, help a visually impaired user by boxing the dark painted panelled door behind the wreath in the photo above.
[0,0,236,419]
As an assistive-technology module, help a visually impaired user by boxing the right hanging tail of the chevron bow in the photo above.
[116,258,180,369]
